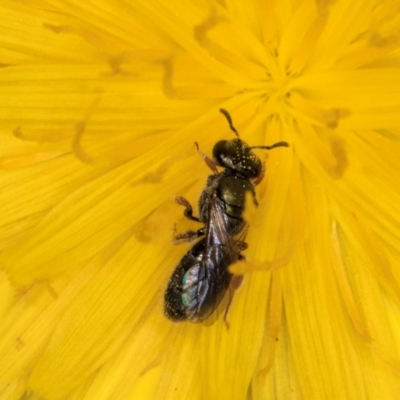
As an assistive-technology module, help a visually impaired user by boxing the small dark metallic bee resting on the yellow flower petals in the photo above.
[164,109,289,322]
